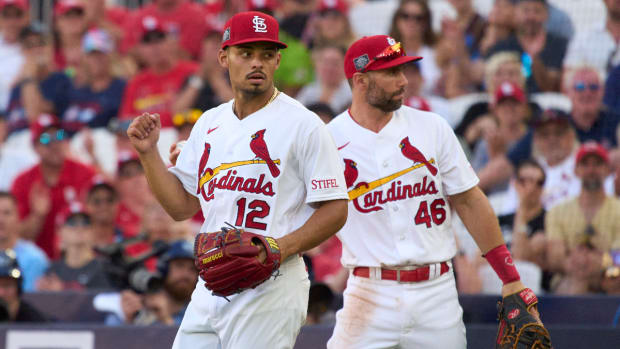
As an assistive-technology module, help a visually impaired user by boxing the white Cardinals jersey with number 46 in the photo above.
[327,106,478,267]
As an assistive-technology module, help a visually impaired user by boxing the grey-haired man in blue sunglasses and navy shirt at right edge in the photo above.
[564,66,620,149]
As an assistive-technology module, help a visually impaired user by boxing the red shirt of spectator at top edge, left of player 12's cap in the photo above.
[122,0,207,58]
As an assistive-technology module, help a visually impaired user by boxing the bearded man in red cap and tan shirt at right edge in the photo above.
[545,142,620,288]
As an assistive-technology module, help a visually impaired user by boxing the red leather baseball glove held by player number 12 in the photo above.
[194,227,281,297]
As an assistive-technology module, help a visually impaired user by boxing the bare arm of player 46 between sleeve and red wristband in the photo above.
[450,187,504,254]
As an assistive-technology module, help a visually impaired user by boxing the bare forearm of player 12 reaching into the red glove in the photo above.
[278,200,348,260]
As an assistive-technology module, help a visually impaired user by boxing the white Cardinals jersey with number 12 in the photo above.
[170,93,347,238]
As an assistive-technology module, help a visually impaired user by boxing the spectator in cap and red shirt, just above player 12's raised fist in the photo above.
[120,17,197,128]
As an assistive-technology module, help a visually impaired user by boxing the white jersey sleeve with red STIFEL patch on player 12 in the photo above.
[298,125,349,203]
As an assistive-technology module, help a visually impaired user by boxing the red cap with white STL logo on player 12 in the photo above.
[222,11,287,48]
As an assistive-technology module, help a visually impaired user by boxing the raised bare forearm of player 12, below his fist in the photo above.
[139,150,200,221]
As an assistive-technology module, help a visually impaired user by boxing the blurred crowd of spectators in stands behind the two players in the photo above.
[0,0,620,325]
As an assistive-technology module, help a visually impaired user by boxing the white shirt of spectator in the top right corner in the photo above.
[564,0,620,73]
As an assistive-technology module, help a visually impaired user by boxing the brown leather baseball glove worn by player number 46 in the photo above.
[495,288,551,349]
